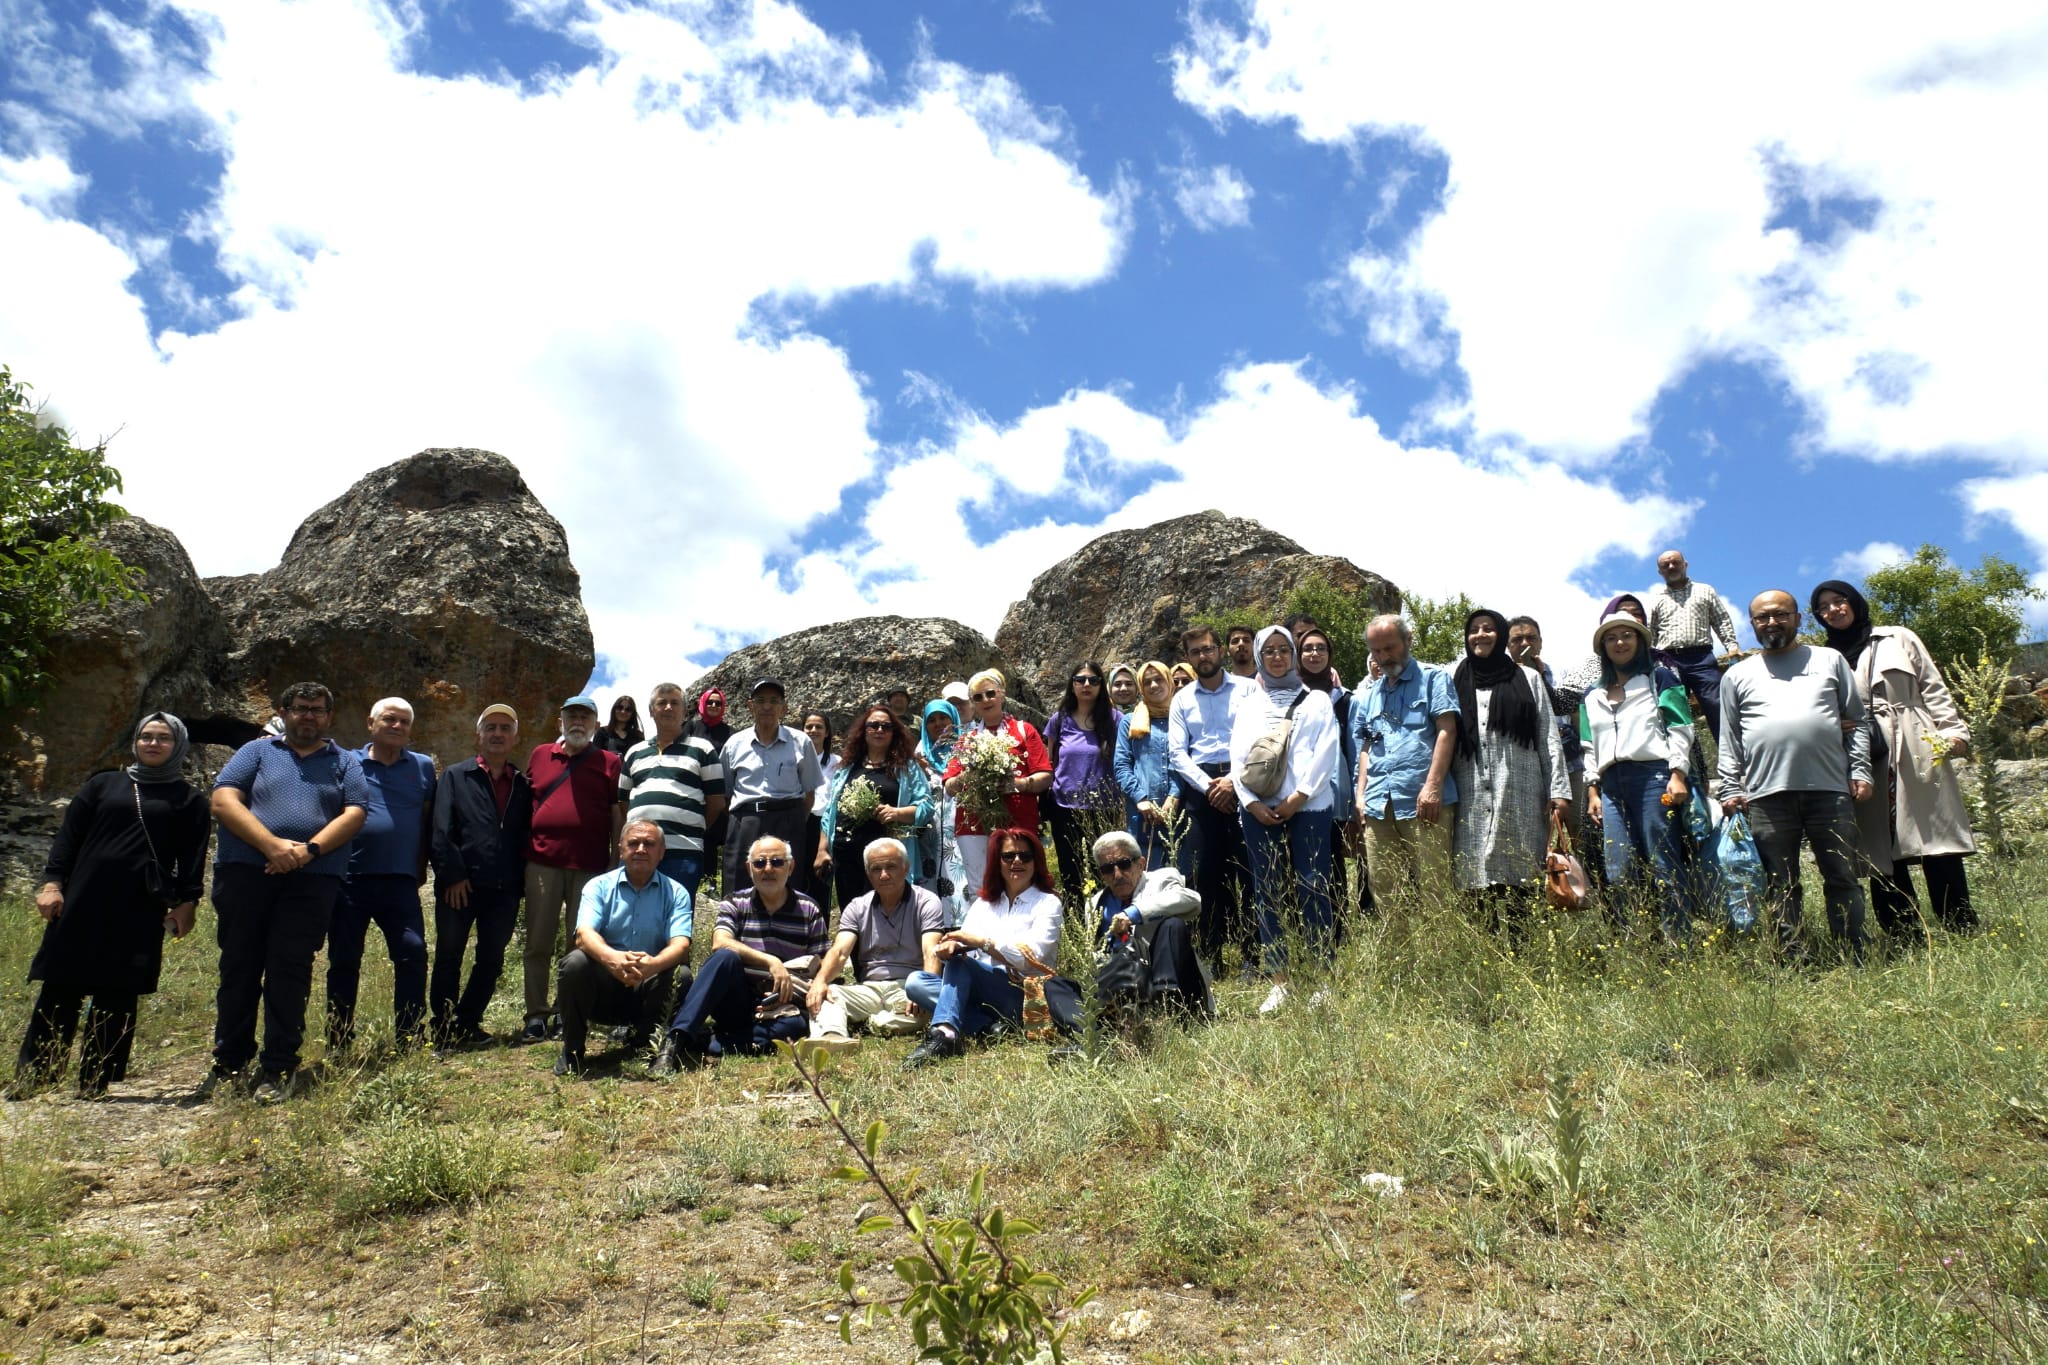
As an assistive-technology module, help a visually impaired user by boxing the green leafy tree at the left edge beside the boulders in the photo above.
[0,366,141,706]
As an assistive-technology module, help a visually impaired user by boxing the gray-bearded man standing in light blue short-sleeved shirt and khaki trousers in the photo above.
[1352,614,1458,909]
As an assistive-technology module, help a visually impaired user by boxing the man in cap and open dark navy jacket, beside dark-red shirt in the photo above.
[426,702,532,1048]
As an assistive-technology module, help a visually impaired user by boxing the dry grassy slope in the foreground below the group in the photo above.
[0,855,2048,1365]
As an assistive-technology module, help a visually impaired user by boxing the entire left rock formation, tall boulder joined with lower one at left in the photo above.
[0,450,594,818]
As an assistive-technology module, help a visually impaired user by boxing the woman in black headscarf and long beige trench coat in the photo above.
[1808,579,1976,937]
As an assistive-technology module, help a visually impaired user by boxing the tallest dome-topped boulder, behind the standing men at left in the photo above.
[209,450,596,763]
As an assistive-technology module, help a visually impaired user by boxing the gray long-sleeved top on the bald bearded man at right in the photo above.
[1718,645,1870,800]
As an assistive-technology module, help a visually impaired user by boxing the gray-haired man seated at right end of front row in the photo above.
[1090,829,1214,1019]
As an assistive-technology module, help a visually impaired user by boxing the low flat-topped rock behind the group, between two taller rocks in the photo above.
[688,616,1044,737]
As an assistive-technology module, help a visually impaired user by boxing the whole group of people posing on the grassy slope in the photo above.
[8,551,1974,1101]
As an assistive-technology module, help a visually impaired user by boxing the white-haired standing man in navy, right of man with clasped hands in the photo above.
[328,696,434,1052]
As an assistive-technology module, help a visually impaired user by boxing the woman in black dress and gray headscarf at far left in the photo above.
[6,710,211,1099]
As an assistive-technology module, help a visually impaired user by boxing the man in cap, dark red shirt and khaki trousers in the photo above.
[520,696,618,1042]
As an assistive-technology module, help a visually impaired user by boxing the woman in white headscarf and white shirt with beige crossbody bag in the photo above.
[1231,626,1337,1015]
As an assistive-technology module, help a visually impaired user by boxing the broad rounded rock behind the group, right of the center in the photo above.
[995,512,1401,706]
